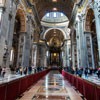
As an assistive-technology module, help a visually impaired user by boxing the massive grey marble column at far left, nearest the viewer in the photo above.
[0,1,16,69]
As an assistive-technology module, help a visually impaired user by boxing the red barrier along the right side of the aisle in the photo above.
[62,71,100,100]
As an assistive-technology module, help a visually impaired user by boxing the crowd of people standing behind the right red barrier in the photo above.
[64,67,100,78]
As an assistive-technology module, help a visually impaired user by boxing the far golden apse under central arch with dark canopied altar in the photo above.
[44,29,65,66]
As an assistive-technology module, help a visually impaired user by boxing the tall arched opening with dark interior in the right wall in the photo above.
[85,9,99,67]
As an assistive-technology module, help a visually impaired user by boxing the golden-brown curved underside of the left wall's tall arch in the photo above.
[16,8,26,32]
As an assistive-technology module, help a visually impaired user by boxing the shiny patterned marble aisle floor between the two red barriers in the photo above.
[16,71,82,100]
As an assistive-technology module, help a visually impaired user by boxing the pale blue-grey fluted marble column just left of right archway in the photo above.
[76,18,87,68]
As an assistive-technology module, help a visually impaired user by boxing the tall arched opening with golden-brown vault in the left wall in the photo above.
[10,9,26,68]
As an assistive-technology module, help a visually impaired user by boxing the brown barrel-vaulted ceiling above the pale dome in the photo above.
[29,0,76,19]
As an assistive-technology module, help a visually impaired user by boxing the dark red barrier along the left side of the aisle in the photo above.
[0,70,50,100]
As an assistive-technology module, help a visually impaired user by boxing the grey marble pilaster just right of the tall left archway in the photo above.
[22,16,32,67]
